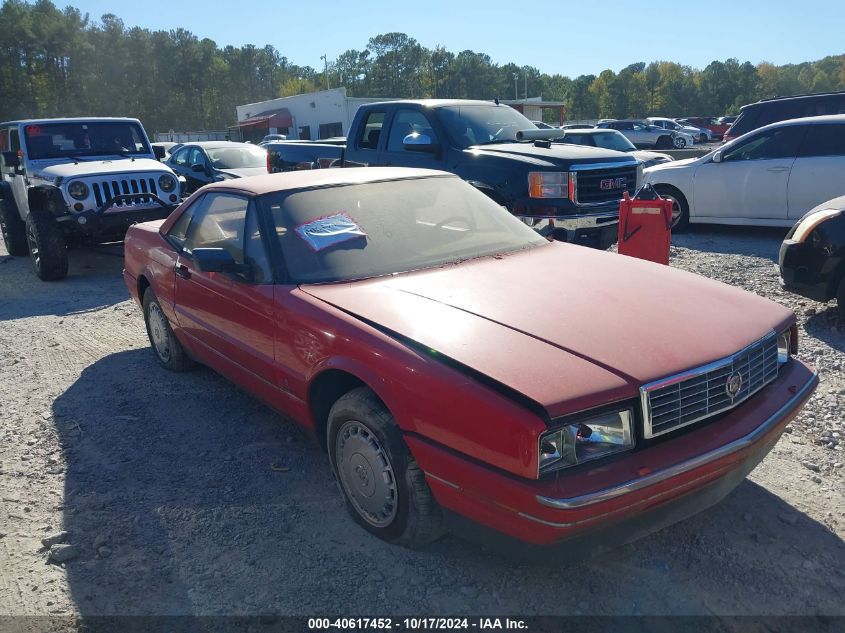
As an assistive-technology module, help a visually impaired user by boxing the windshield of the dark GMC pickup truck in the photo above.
[440,104,537,148]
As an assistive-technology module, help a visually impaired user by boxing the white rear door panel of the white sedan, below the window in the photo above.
[787,156,845,221]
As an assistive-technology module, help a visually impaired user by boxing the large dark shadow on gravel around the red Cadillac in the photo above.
[53,349,845,616]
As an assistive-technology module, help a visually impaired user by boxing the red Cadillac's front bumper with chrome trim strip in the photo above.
[407,359,818,549]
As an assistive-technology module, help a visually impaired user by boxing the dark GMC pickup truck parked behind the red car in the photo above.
[266,99,642,248]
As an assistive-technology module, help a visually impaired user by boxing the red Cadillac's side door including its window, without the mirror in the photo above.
[175,192,275,382]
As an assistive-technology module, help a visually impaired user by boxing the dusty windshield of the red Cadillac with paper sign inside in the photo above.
[259,176,548,283]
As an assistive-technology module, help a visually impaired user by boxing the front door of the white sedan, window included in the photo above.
[690,125,808,220]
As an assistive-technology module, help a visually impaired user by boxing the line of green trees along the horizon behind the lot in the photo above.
[0,0,845,131]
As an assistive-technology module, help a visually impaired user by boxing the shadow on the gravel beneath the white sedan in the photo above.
[672,224,789,263]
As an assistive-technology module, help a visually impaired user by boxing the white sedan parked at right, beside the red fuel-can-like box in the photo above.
[644,114,845,230]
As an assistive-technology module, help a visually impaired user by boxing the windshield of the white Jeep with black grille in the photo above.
[24,121,152,159]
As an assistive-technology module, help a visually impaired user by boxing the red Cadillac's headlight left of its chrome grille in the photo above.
[539,407,634,474]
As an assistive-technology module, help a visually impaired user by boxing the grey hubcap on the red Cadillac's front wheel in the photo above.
[335,420,399,527]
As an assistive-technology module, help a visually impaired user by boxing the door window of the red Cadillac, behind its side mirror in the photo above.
[184,193,249,264]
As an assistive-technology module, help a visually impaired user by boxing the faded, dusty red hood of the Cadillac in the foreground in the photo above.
[302,242,793,414]
